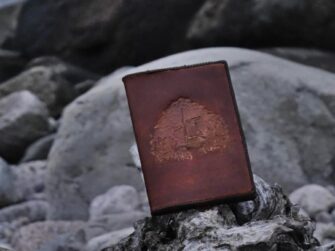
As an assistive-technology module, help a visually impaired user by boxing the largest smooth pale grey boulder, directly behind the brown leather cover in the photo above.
[47,48,335,221]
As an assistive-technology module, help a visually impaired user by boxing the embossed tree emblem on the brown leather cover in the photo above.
[150,98,229,162]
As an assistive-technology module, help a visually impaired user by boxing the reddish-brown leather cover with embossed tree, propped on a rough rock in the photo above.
[123,61,254,215]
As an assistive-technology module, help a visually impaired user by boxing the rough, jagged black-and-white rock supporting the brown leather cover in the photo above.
[104,176,318,251]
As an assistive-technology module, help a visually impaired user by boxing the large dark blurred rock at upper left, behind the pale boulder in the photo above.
[15,0,204,73]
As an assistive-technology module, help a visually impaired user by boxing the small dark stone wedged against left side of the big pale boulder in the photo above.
[20,134,55,163]
